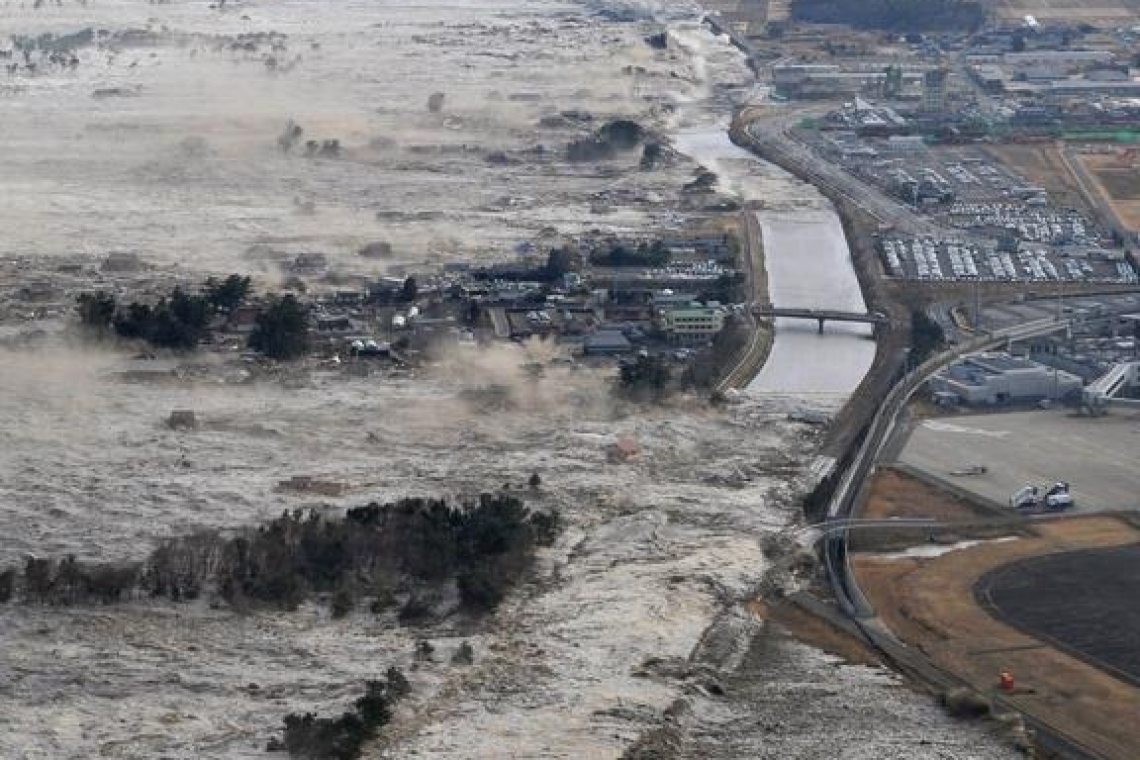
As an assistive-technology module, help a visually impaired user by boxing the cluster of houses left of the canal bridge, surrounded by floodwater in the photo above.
[285,232,735,359]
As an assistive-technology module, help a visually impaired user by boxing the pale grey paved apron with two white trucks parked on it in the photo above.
[898,409,1140,513]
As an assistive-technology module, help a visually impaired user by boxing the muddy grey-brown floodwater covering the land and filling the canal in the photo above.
[0,0,1010,760]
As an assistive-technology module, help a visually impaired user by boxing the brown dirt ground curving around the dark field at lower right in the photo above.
[855,516,1140,760]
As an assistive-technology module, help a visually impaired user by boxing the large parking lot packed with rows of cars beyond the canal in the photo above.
[799,130,1140,284]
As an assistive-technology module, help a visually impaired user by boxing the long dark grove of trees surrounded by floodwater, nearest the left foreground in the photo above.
[0,493,560,619]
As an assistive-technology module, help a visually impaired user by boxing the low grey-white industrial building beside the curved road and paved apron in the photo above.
[930,353,1082,406]
